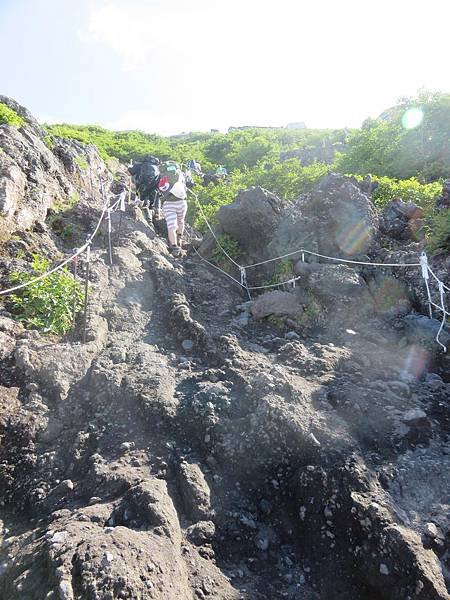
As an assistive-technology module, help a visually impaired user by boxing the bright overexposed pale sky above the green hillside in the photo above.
[0,0,450,135]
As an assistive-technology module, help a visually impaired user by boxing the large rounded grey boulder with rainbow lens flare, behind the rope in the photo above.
[269,174,378,257]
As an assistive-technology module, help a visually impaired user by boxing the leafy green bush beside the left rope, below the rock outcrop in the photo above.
[10,254,83,335]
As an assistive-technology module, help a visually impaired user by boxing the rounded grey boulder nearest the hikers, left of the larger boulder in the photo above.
[217,186,282,254]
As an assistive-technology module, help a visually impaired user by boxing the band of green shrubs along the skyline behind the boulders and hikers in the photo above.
[47,92,450,248]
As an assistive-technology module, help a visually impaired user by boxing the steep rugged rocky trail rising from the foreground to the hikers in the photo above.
[0,207,449,600]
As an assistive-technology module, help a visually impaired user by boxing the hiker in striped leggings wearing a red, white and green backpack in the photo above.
[158,160,187,256]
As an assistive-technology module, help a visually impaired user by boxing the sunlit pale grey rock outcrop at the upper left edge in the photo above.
[0,96,108,241]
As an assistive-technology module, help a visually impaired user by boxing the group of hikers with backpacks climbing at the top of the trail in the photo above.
[128,156,228,256]
